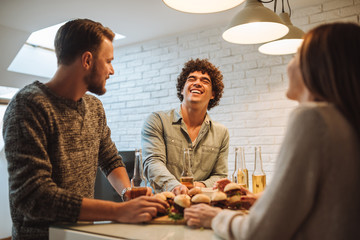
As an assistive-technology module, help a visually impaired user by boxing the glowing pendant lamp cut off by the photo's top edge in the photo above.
[163,0,245,13]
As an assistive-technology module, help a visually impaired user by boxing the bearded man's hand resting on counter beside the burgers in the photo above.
[115,196,169,223]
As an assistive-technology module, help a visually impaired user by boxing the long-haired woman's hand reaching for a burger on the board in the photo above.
[184,204,222,228]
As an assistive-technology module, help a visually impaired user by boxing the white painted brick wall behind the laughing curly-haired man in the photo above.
[97,0,360,186]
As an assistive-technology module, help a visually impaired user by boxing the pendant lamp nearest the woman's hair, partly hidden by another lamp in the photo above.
[259,12,305,55]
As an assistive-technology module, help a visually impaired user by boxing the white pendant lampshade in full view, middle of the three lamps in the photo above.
[222,0,289,44]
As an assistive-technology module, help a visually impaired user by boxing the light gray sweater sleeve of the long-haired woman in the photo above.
[213,107,326,240]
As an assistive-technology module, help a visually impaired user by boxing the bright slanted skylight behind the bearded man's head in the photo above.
[8,23,125,78]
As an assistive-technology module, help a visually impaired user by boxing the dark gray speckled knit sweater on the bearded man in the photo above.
[3,82,124,239]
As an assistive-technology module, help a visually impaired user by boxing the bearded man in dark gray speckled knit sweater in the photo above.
[3,19,167,240]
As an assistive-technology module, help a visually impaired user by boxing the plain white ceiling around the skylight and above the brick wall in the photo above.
[0,0,319,87]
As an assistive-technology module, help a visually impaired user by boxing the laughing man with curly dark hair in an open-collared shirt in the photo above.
[141,59,229,194]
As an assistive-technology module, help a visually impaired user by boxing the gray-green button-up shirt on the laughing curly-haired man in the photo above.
[141,108,229,191]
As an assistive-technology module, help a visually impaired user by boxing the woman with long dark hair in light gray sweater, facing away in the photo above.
[185,23,360,240]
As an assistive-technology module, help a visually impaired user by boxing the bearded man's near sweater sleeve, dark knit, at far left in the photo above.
[3,94,82,222]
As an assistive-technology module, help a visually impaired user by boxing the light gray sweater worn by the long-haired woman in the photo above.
[212,103,360,240]
